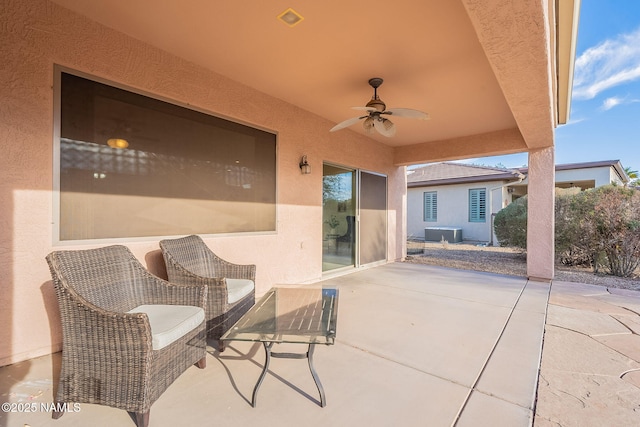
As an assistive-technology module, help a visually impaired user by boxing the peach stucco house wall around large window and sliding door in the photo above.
[0,0,406,365]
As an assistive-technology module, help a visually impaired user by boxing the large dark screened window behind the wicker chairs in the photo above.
[56,71,276,241]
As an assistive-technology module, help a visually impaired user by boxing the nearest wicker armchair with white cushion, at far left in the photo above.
[46,245,207,427]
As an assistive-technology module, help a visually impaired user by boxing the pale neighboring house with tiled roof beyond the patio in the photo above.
[407,160,629,243]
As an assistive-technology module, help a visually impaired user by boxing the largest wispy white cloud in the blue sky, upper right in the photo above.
[573,28,640,100]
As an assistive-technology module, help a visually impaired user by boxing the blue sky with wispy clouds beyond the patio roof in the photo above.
[464,0,640,171]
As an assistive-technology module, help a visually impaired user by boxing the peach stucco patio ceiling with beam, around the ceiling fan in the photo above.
[54,0,568,151]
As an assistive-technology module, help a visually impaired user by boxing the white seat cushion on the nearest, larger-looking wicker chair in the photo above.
[129,304,204,350]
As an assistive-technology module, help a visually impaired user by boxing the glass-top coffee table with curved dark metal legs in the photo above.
[220,286,338,408]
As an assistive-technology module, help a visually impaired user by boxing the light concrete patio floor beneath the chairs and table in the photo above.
[0,263,640,427]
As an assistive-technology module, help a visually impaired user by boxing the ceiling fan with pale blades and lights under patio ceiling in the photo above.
[329,77,429,137]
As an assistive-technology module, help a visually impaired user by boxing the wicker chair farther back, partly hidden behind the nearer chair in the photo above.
[160,235,256,351]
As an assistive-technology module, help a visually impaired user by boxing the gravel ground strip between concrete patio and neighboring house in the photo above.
[405,241,640,290]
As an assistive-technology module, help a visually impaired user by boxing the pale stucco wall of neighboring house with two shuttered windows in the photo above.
[407,181,511,242]
